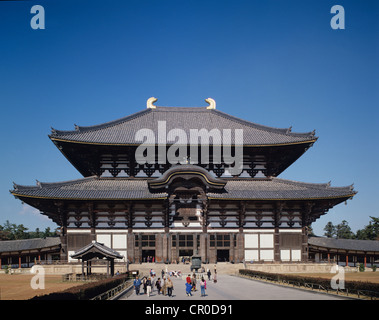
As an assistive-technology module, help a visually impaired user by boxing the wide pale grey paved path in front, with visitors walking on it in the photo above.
[120,275,343,301]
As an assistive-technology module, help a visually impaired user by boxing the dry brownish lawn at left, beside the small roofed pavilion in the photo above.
[0,274,82,300]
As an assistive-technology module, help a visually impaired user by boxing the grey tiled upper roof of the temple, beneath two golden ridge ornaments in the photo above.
[49,107,317,146]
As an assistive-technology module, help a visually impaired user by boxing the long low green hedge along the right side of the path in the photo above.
[239,269,379,297]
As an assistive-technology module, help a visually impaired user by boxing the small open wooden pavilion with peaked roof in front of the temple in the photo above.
[71,241,123,276]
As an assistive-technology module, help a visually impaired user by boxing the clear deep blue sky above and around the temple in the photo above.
[0,0,379,235]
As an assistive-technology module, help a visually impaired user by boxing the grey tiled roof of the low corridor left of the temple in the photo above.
[0,237,61,252]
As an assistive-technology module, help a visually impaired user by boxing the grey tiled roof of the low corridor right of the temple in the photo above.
[308,237,379,252]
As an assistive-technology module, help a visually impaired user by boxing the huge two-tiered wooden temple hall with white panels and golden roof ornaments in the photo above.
[11,98,356,263]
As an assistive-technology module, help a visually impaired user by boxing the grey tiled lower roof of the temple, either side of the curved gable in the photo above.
[11,176,356,200]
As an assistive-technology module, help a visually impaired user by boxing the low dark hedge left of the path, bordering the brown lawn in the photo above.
[30,274,129,300]
